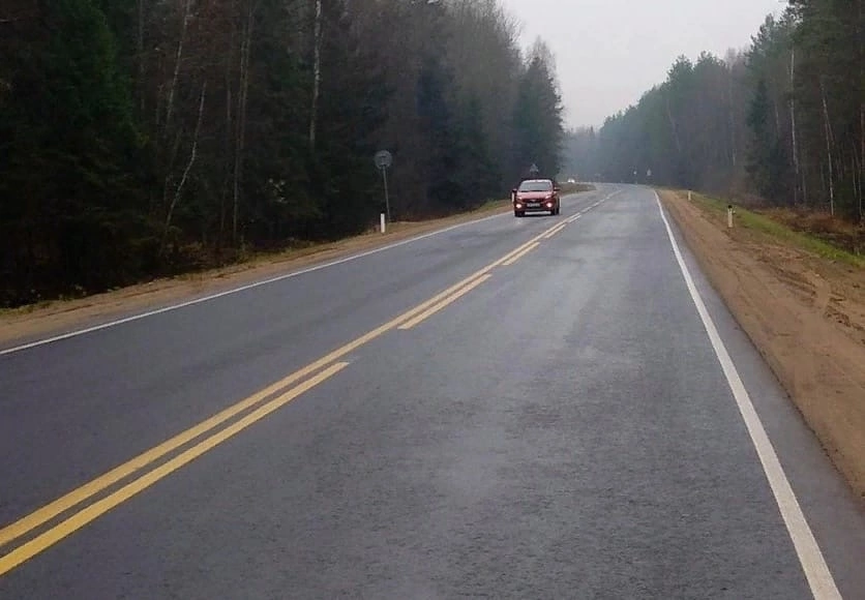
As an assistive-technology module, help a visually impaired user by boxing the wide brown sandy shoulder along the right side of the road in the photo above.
[659,191,865,498]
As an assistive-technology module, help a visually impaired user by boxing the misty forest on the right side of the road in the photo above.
[566,0,865,221]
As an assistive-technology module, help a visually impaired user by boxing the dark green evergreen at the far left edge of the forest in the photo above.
[0,0,148,303]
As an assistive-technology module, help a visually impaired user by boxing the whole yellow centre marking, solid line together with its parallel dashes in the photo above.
[0,213,580,576]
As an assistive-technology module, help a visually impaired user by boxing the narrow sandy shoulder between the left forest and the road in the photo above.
[0,201,511,346]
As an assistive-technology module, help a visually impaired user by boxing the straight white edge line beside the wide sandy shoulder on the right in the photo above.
[655,191,841,600]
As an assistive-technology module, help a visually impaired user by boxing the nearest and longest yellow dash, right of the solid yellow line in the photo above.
[0,362,348,576]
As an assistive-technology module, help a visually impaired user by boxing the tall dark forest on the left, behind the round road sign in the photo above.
[0,0,563,306]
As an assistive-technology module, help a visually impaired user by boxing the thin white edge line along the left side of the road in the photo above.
[0,213,510,356]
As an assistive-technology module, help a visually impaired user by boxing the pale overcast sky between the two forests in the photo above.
[502,0,786,126]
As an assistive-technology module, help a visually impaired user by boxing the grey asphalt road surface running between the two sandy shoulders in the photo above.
[0,185,865,600]
